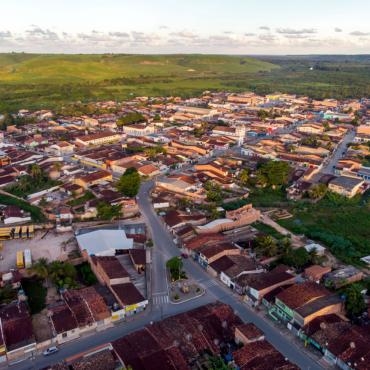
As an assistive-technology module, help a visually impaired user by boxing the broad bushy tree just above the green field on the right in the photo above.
[257,161,290,187]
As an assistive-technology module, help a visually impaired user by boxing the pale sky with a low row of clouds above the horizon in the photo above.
[0,0,370,55]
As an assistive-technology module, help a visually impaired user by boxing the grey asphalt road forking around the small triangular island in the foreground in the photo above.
[10,182,323,370]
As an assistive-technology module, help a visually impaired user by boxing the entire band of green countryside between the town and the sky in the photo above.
[0,53,370,113]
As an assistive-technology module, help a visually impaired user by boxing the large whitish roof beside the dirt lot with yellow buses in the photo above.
[76,229,133,258]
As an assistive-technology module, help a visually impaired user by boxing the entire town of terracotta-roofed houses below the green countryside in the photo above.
[0,91,370,370]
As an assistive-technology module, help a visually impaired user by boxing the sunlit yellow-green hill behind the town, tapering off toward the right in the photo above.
[0,53,279,110]
